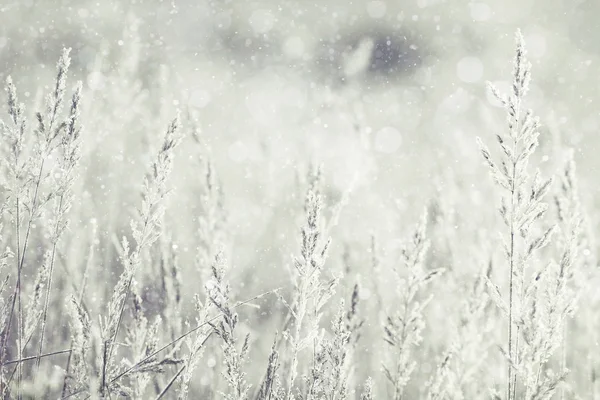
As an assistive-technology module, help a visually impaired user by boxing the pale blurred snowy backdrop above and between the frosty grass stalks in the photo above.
[0,0,600,394]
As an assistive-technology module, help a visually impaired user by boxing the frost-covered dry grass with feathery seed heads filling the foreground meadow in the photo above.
[0,28,597,400]
